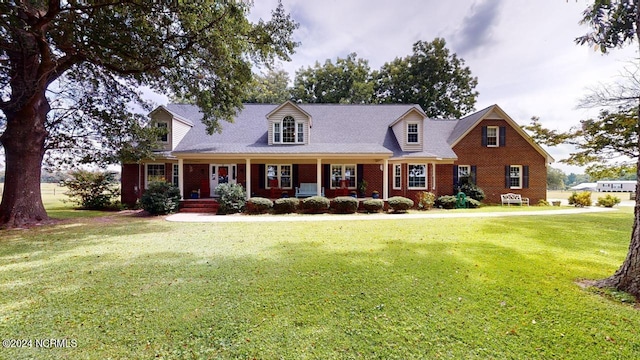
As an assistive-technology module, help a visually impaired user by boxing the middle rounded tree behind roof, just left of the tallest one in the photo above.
[292,53,373,104]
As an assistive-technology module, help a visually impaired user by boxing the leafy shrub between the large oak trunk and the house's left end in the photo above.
[61,170,120,210]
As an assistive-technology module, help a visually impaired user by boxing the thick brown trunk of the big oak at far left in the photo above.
[0,91,50,228]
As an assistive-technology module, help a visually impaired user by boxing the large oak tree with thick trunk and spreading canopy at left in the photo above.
[0,0,297,227]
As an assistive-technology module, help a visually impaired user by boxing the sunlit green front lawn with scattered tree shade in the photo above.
[0,190,640,359]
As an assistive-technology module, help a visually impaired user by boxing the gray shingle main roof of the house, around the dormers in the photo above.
[166,104,459,159]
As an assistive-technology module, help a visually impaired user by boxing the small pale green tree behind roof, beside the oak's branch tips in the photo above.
[244,69,291,104]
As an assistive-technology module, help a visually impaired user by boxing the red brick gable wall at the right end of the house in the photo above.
[452,120,547,204]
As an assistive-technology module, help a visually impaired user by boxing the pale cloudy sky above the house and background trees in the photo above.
[251,0,638,172]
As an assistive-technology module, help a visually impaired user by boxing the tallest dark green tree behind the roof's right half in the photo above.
[373,38,478,118]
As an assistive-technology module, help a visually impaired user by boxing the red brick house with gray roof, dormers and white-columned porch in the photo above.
[122,102,553,204]
